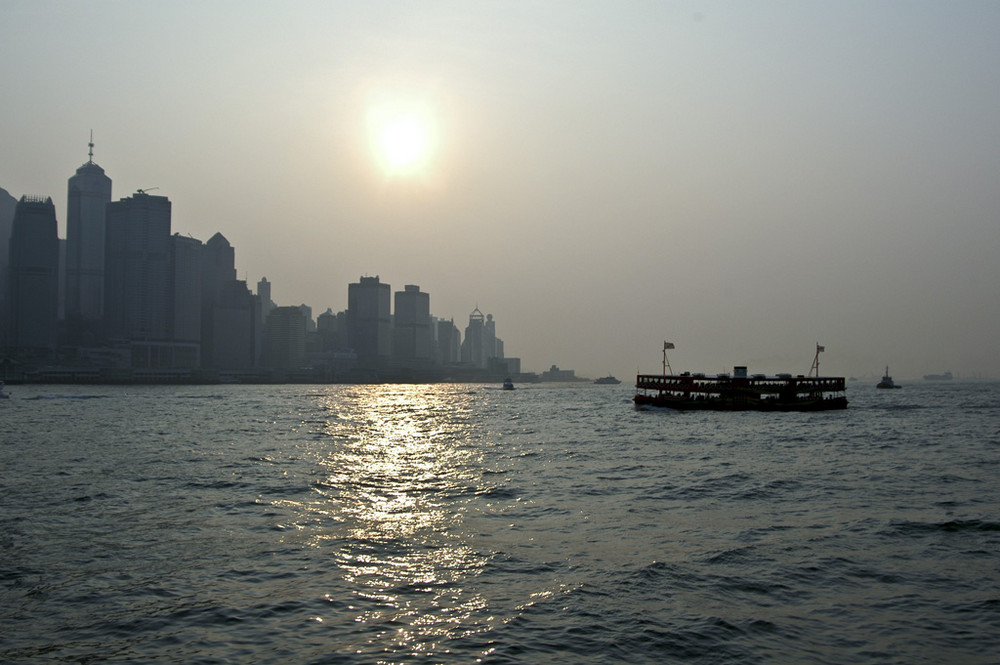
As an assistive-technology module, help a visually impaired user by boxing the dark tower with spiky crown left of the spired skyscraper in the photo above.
[6,196,59,360]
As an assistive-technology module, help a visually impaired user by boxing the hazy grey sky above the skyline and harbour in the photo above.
[0,0,1000,380]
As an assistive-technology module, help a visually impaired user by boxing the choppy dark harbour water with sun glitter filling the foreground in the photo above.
[0,383,1000,665]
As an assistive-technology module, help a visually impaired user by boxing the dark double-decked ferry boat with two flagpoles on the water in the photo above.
[633,345,847,411]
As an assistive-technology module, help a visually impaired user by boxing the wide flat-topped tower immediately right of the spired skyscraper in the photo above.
[104,190,172,367]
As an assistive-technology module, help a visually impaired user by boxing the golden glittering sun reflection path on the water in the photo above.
[304,386,494,655]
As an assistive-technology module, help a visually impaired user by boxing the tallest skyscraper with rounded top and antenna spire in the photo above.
[65,140,111,332]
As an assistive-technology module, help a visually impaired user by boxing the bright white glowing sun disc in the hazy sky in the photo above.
[368,101,435,178]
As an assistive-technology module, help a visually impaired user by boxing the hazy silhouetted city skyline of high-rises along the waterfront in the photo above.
[0,172,521,382]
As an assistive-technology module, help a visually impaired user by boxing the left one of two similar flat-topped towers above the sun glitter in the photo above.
[347,275,392,369]
